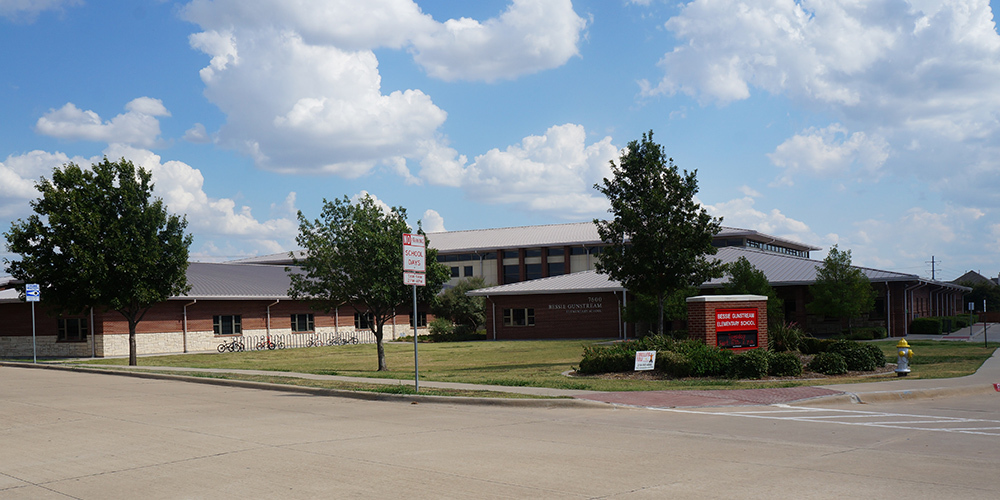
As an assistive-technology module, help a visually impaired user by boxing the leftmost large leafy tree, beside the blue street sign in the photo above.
[5,158,191,366]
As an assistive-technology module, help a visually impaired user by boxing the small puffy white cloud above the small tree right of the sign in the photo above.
[767,124,889,185]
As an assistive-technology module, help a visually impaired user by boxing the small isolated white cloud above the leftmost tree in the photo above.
[35,97,170,147]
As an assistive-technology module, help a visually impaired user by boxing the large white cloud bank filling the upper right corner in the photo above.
[643,0,1000,200]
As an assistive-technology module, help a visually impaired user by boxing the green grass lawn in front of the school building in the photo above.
[72,340,1000,392]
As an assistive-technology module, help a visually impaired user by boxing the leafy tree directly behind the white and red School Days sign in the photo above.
[286,194,450,371]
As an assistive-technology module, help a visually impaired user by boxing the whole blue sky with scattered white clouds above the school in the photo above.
[0,0,1000,280]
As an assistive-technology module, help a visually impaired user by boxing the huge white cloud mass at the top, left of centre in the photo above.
[183,0,585,178]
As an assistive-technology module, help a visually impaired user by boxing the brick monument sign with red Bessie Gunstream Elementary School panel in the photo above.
[687,295,767,350]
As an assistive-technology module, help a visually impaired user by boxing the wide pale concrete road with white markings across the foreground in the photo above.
[0,367,1000,499]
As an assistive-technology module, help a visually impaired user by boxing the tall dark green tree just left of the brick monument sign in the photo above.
[594,130,722,334]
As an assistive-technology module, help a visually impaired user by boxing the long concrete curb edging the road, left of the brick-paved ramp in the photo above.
[0,361,613,409]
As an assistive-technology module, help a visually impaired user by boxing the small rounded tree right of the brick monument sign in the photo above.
[806,245,875,331]
